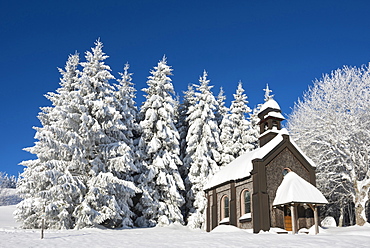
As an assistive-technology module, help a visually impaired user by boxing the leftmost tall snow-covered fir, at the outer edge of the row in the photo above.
[15,54,85,229]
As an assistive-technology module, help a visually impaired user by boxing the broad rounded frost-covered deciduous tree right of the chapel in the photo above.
[287,66,370,225]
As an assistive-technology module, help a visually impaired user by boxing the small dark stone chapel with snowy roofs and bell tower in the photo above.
[204,98,327,233]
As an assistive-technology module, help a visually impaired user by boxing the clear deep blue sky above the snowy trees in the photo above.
[0,0,370,175]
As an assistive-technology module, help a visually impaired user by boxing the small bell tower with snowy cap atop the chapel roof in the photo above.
[258,97,285,147]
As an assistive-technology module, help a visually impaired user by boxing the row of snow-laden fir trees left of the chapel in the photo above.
[15,40,260,229]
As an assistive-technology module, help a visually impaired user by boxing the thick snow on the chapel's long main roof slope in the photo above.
[204,128,288,189]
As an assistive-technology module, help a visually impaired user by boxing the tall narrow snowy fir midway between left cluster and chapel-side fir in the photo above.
[136,57,185,226]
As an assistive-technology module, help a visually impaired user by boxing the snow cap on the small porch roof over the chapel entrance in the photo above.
[272,171,328,206]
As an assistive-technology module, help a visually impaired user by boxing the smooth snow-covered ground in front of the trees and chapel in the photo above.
[0,205,370,248]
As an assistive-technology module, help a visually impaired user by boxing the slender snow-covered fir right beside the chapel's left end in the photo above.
[184,71,221,228]
